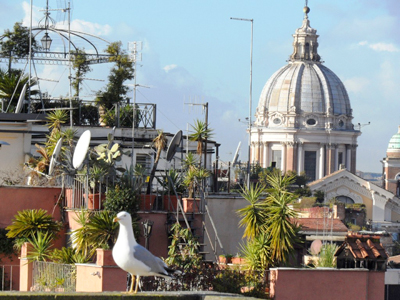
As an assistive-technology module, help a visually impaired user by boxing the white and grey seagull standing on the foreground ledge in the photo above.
[112,211,181,294]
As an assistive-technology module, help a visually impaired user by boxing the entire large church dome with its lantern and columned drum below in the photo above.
[250,7,361,181]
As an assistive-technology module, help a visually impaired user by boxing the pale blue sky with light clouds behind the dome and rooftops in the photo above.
[0,0,400,173]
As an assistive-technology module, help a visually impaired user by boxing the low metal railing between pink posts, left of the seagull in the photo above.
[32,261,76,292]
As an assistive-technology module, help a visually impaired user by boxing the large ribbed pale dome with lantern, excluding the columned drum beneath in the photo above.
[255,9,353,130]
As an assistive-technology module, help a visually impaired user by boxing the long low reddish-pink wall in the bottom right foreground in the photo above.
[270,268,385,300]
